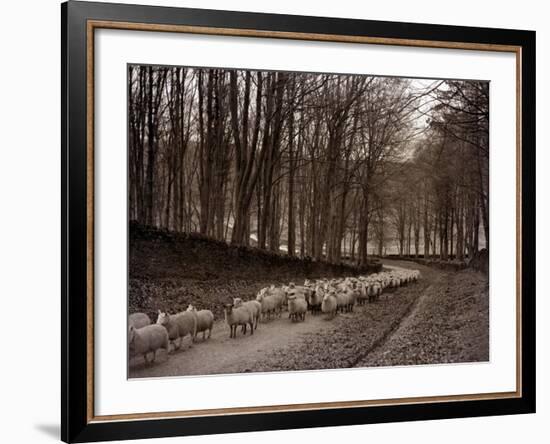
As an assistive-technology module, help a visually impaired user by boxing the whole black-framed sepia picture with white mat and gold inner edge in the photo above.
[61,1,535,442]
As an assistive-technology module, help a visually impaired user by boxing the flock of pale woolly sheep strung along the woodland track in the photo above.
[128,268,420,362]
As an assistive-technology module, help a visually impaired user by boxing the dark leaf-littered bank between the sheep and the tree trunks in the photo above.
[128,224,381,319]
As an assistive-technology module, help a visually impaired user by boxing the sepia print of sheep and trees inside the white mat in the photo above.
[127,64,490,378]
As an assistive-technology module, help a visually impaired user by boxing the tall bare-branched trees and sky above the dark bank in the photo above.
[127,65,489,265]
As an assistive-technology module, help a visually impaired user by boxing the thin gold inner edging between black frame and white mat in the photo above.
[86,20,522,423]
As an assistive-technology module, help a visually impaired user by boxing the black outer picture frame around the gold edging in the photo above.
[61,1,535,442]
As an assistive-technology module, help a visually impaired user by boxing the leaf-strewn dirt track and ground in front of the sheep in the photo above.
[129,261,489,378]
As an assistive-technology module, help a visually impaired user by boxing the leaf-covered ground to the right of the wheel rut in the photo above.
[357,260,489,367]
